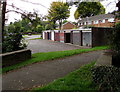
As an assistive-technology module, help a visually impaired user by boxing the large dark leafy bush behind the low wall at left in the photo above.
[2,24,26,53]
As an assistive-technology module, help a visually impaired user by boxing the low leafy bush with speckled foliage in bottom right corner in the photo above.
[92,66,120,92]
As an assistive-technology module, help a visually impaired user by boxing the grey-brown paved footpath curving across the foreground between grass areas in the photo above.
[2,51,102,90]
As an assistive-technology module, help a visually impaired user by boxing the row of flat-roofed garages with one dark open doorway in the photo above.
[43,27,111,47]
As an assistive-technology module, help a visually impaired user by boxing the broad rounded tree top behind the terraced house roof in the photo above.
[74,2,105,19]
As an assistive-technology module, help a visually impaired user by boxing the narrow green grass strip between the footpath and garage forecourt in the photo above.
[2,46,108,73]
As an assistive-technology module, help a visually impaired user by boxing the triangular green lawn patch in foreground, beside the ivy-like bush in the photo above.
[31,62,97,92]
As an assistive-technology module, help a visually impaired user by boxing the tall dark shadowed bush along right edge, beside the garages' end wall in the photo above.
[110,23,120,67]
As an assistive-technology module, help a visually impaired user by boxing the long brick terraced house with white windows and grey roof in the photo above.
[78,14,117,27]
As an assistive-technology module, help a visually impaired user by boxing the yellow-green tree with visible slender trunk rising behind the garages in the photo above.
[48,2,70,29]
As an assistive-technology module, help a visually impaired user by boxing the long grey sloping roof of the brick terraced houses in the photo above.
[78,14,115,22]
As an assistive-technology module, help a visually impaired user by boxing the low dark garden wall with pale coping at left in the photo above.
[0,49,31,67]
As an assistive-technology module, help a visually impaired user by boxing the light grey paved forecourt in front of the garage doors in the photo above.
[28,39,85,53]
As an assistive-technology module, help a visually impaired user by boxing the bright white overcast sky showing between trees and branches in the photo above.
[6,0,118,24]
